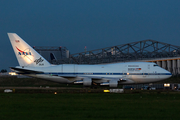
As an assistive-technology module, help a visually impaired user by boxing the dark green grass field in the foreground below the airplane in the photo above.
[0,93,180,120]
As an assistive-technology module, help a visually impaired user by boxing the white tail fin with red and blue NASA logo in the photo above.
[8,33,50,67]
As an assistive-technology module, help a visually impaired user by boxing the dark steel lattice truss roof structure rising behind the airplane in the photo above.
[57,40,180,64]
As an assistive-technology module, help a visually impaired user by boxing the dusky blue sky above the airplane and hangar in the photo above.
[0,0,180,70]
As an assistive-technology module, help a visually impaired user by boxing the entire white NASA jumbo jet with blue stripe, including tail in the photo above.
[8,33,172,87]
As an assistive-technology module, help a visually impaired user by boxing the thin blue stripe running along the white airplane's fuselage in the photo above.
[44,72,172,75]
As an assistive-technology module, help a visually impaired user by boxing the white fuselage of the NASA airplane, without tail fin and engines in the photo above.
[19,62,171,84]
